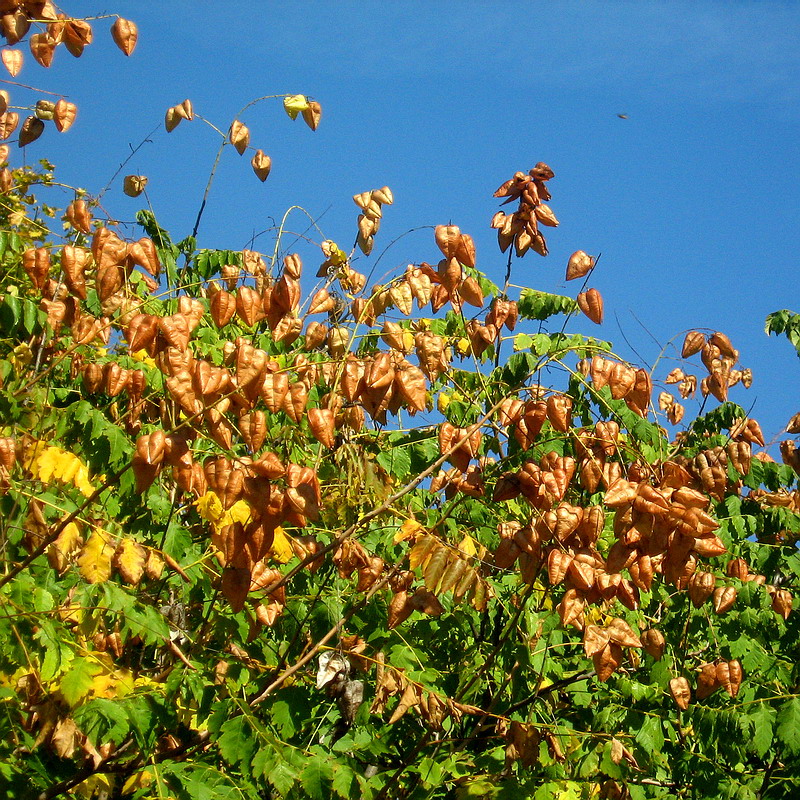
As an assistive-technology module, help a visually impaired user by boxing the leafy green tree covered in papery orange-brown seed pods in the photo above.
[0,2,800,799]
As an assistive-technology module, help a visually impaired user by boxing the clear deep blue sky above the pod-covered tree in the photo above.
[11,0,800,444]
